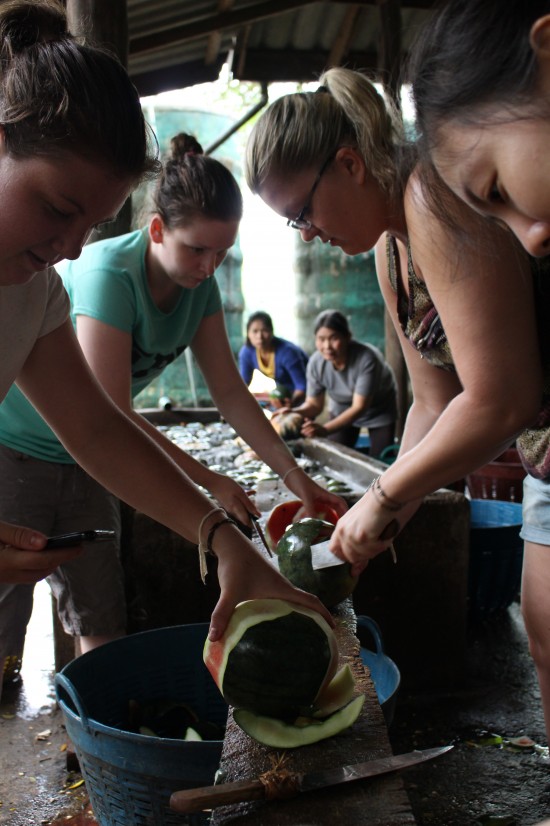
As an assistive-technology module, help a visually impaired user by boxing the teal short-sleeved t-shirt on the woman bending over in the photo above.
[0,230,222,464]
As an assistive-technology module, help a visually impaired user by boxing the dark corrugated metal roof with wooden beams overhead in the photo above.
[127,0,433,95]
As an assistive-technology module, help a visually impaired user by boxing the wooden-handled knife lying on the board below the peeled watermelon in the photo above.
[170,745,453,813]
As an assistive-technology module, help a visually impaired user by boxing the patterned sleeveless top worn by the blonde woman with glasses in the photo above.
[386,235,550,481]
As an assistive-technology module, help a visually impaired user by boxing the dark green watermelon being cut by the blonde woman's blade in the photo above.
[276,519,358,608]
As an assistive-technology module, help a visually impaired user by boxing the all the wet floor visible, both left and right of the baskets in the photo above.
[0,589,550,826]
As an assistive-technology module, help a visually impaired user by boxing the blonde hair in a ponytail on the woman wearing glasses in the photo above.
[244,68,403,193]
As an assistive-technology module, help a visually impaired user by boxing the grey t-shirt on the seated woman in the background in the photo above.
[307,339,397,427]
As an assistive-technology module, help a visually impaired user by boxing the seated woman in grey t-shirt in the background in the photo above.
[294,310,397,457]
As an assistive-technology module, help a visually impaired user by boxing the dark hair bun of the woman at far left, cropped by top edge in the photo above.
[0,0,70,54]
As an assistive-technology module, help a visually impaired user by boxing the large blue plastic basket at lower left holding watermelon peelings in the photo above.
[55,623,228,826]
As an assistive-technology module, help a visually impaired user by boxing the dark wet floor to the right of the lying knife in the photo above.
[389,603,550,826]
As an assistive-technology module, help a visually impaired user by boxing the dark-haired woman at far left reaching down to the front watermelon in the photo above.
[0,0,336,692]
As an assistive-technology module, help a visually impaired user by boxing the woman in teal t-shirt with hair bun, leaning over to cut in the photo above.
[0,127,345,668]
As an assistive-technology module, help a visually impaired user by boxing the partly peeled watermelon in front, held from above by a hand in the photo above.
[204,599,362,748]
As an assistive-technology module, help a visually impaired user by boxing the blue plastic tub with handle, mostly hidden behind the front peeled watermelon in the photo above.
[357,615,401,725]
